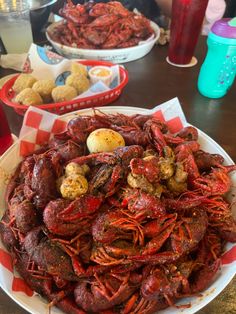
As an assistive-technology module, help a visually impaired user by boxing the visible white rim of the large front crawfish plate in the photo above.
[0,106,236,314]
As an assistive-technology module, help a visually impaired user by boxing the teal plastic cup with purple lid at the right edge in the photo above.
[198,18,236,98]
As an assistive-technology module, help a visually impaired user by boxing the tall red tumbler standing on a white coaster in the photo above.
[168,0,208,65]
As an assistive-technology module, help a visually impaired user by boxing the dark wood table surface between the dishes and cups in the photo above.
[0,37,236,314]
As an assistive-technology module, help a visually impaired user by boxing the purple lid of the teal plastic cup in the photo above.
[211,18,236,39]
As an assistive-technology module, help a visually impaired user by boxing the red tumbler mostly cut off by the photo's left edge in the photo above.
[0,104,13,155]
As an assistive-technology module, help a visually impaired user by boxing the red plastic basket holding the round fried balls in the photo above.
[0,60,128,115]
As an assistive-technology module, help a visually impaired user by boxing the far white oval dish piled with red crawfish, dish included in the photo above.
[46,0,160,63]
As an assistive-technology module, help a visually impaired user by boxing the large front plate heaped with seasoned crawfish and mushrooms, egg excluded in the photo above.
[0,107,236,314]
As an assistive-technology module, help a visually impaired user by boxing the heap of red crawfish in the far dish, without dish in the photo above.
[50,0,154,49]
